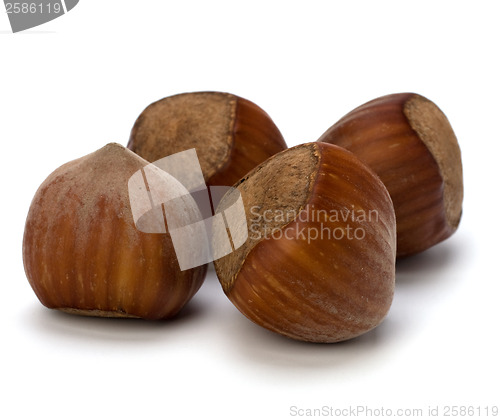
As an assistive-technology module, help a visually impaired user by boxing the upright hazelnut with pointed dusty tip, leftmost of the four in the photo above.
[23,144,206,319]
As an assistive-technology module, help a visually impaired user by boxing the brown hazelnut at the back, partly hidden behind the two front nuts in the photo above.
[127,92,287,185]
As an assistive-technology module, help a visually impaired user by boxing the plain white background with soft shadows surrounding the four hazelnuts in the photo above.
[0,0,500,420]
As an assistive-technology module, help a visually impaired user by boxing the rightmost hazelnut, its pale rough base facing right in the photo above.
[318,93,463,257]
